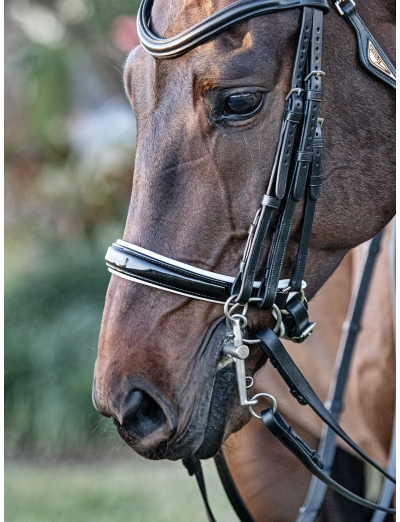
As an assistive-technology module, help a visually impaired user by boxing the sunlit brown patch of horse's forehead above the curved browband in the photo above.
[152,0,231,38]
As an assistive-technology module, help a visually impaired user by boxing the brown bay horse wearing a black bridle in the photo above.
[93,0,395,521]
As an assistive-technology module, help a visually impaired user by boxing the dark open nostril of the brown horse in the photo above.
[119,390,167,437]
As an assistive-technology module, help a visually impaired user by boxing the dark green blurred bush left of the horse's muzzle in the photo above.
[5,234,119,452]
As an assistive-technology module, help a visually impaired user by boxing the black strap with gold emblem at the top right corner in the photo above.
[337,1,396,89]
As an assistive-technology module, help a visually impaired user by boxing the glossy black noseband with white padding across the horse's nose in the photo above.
[106,239,306,304]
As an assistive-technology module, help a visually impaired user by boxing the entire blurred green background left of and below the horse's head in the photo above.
[5,0,234,522]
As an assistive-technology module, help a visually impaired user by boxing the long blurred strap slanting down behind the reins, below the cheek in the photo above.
[296,231,384,522]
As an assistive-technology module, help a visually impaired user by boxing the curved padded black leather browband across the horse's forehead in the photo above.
[137,0,329,58]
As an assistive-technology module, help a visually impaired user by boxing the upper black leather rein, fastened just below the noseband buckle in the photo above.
[257,328,396,482]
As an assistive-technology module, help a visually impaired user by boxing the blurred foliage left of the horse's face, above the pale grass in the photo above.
[5,0,138,455]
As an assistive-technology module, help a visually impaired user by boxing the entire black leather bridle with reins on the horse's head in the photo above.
[106,0,396,521]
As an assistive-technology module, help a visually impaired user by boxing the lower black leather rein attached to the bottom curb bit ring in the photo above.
[261,407,396,514]
